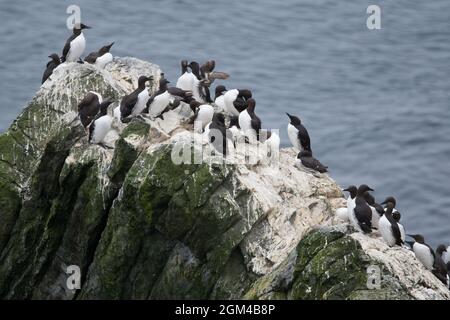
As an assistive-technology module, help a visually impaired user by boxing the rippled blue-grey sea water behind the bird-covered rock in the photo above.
[0,0,450,246]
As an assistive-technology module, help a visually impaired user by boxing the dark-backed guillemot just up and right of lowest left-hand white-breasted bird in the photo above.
[118,76,153,122]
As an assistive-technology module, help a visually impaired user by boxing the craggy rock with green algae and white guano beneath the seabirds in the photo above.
[0,58,450,299]
